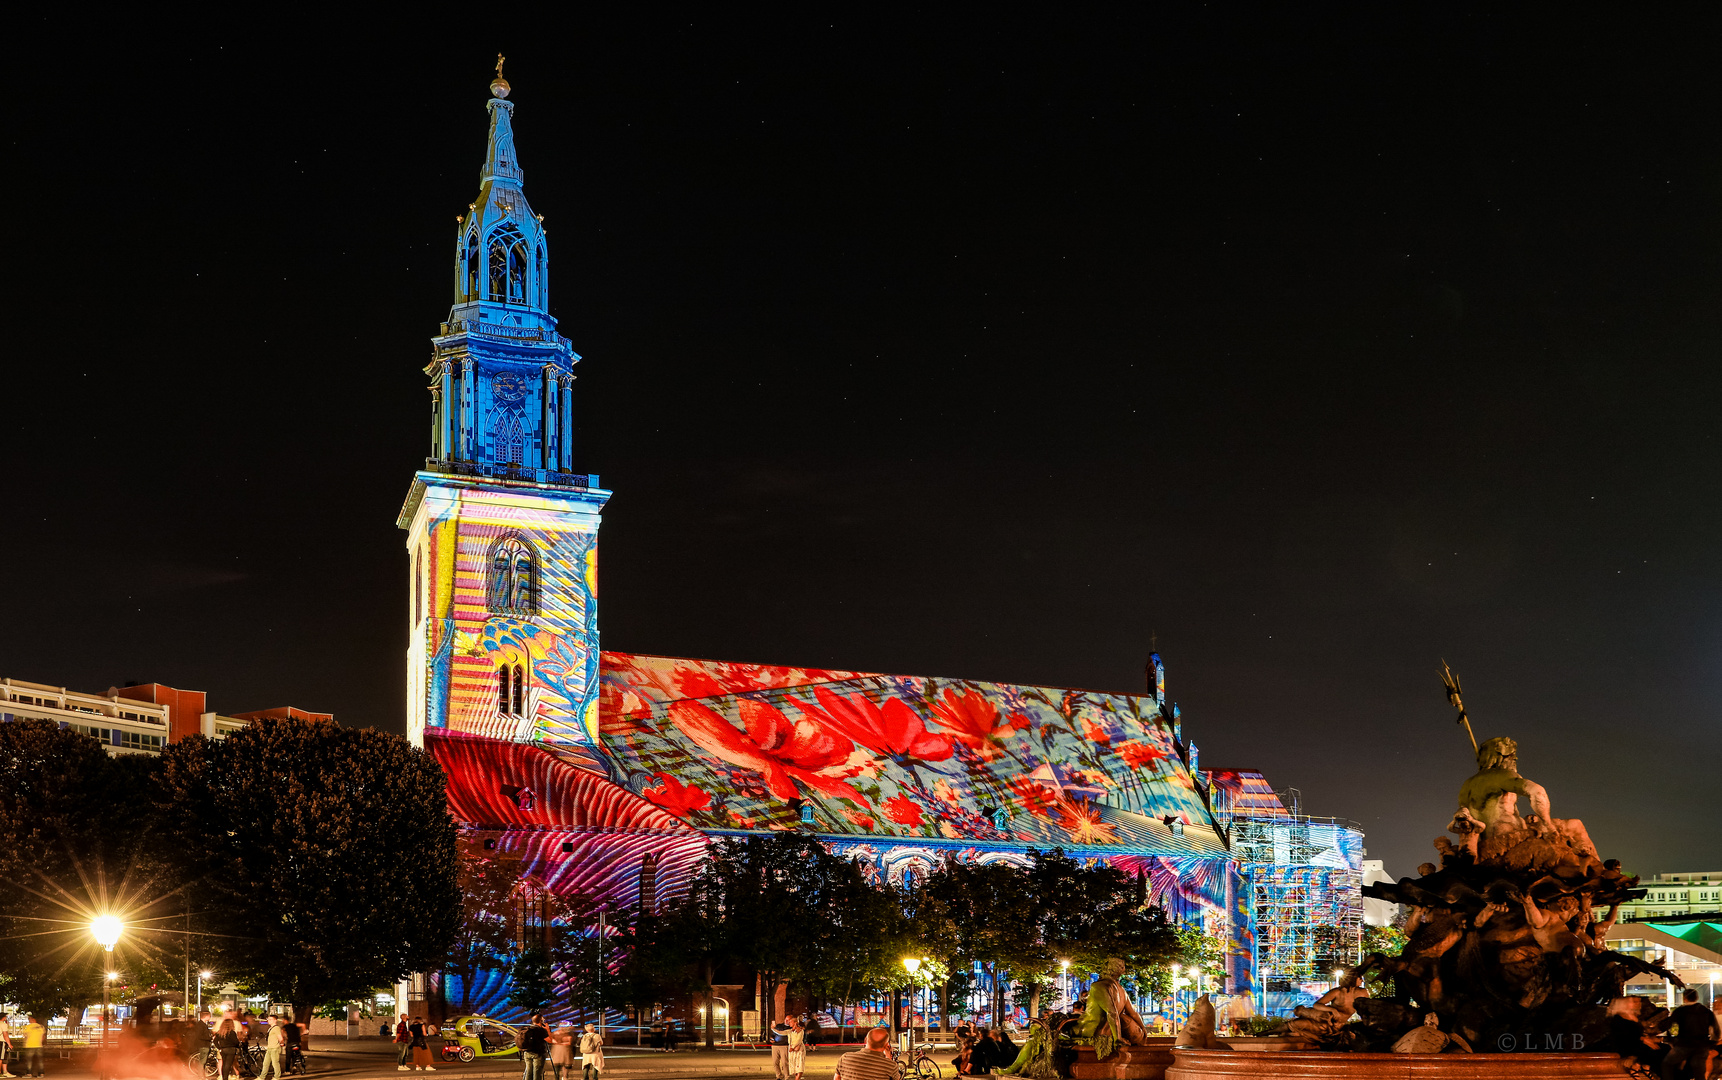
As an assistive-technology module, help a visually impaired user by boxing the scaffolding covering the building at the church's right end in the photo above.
[1231,789,1364,1013]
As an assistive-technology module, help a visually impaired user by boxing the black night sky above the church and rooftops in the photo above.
[0,5,1722,875]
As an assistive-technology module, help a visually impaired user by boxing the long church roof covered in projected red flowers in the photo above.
[599,653,1224,854]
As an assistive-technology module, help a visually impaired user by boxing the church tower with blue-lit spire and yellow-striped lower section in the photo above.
[398,60,610,768]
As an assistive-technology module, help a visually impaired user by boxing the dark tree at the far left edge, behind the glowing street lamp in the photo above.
[0,720,162,1015]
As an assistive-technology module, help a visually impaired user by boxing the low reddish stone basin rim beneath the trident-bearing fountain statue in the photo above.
[1157,1049,1626,1080]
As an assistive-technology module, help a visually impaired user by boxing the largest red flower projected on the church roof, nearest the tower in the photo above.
[670,698,868,806]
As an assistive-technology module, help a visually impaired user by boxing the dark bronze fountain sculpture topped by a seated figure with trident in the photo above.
[1290,665,1681,1052]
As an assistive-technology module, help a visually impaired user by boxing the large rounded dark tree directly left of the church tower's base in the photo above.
[155,720,460,1015]
